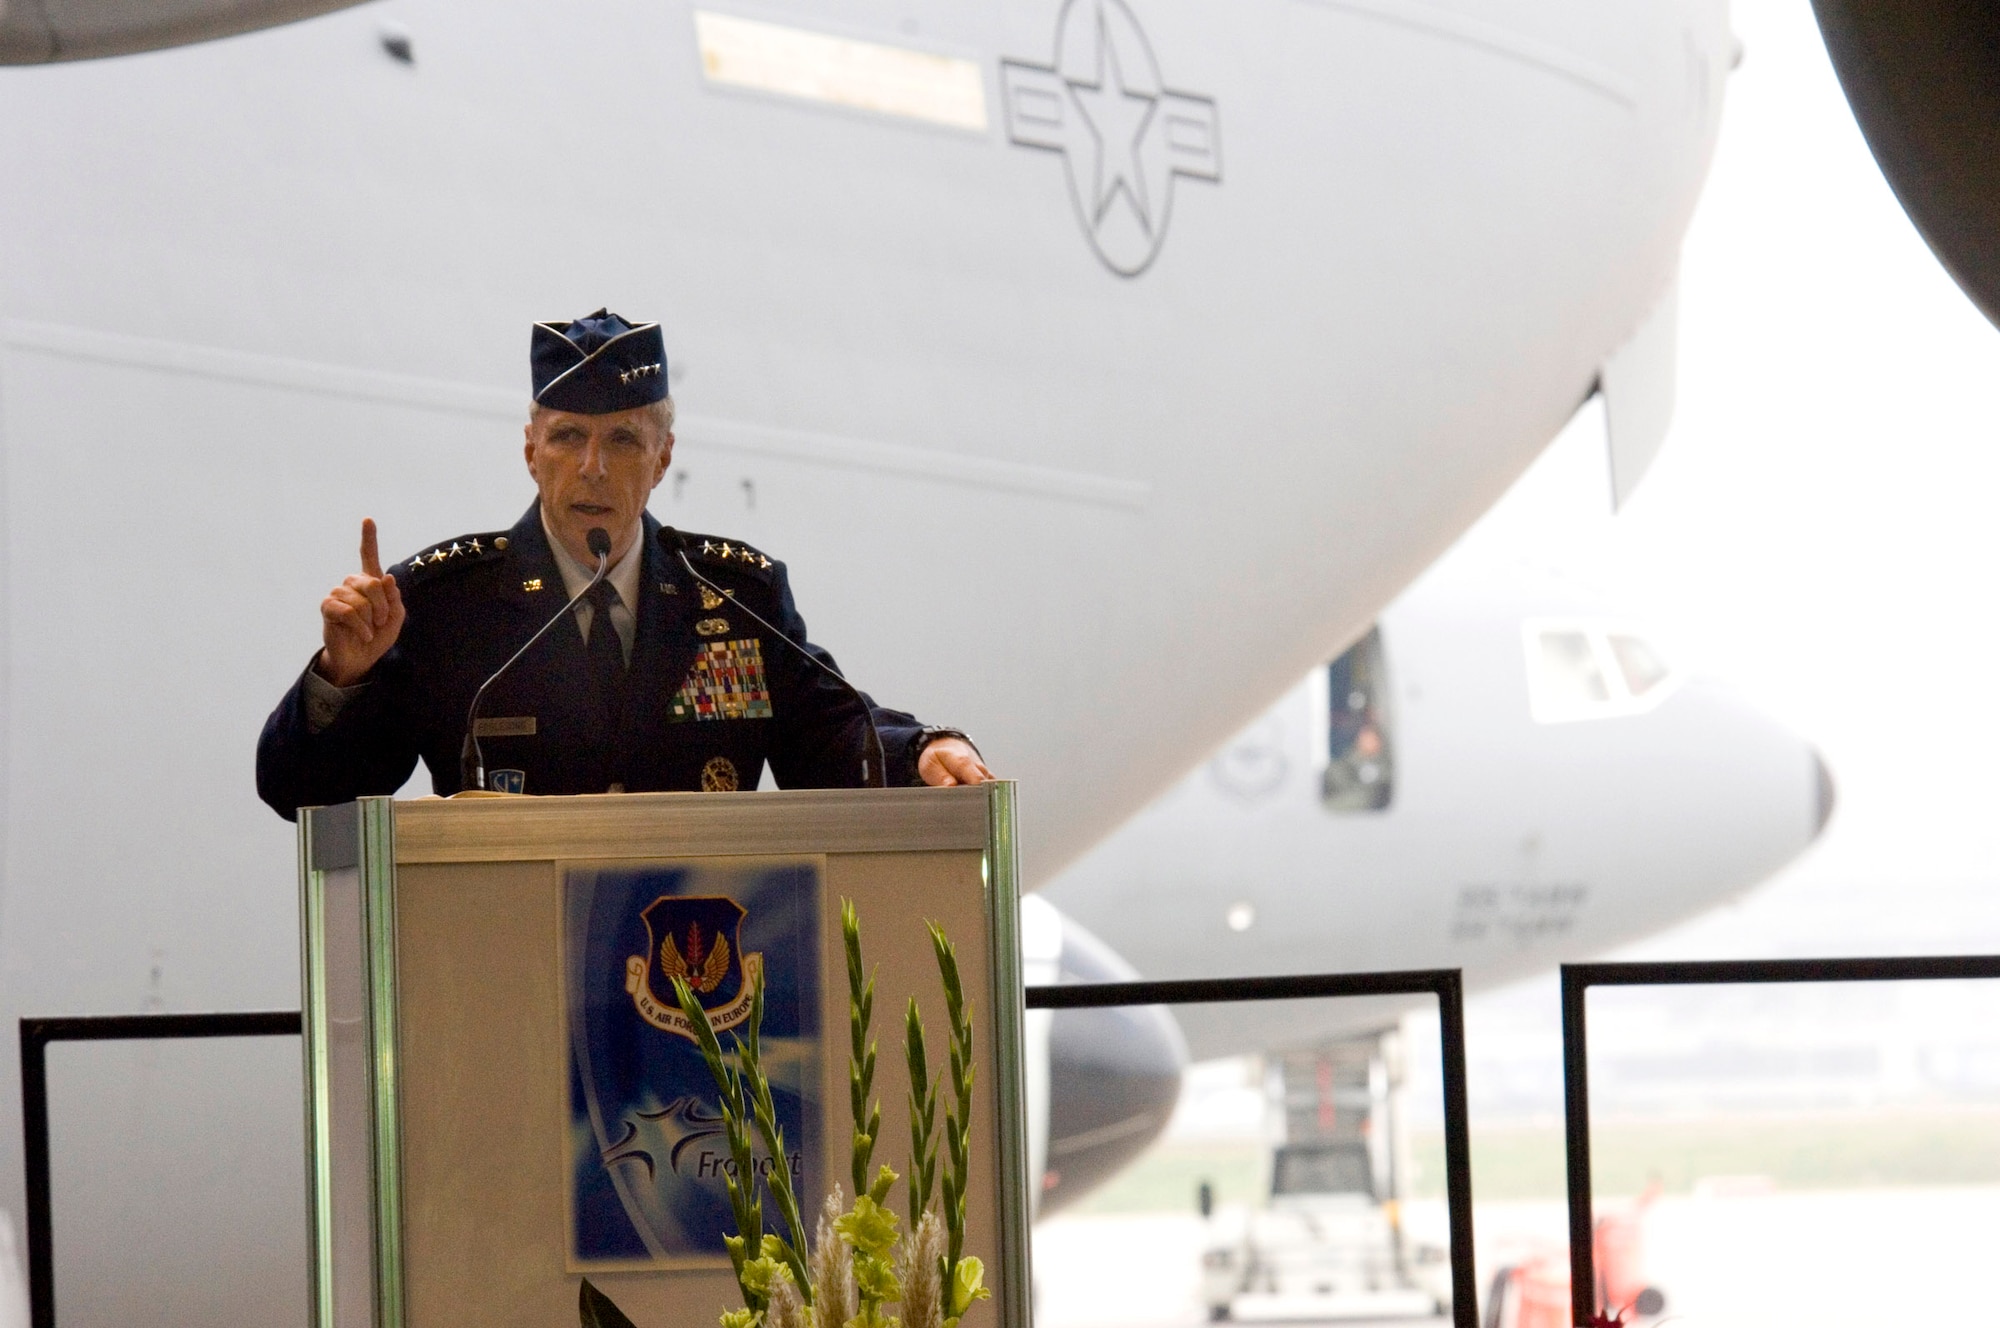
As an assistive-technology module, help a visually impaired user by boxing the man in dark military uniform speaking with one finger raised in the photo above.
[256,310,992,818]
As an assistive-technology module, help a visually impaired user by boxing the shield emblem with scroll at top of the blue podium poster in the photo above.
[626,894,764,1042]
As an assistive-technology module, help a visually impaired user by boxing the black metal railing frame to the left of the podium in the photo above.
[20,1010,300,1328]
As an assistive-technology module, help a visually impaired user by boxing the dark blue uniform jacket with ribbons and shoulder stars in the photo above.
[256,506,924,820]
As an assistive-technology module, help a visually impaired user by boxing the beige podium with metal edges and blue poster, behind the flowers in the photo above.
[298,782,1030,1328]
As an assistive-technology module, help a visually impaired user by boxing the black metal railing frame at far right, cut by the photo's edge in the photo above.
[1562,954,2000,1328]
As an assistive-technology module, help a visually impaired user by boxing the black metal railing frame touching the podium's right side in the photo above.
[1028,968,1480,1328]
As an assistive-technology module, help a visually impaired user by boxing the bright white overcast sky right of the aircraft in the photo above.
[1544,0,2000,956]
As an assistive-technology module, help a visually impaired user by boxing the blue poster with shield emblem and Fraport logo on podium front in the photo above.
[564,858,824,1272]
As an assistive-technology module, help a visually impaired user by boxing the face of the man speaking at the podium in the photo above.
[524,406,674,566]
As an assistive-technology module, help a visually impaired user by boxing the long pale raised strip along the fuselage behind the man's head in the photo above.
[0,320,1152,512]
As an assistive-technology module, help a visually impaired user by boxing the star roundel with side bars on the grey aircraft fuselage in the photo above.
[1000,0,1222,276]
